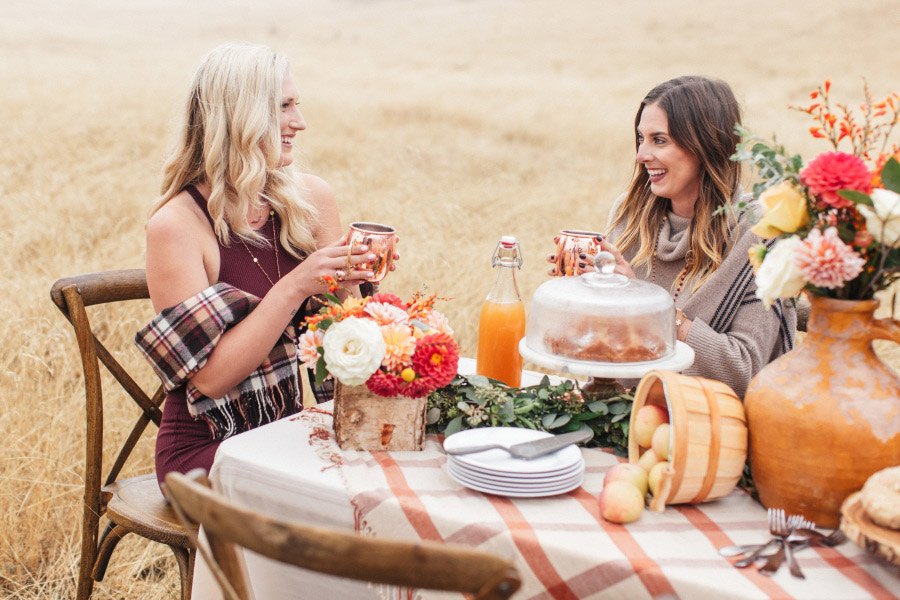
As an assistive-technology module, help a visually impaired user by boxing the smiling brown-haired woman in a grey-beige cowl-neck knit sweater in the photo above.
[551,76,796,396]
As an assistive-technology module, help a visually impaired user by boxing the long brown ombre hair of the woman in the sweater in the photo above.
[612,76,741,291]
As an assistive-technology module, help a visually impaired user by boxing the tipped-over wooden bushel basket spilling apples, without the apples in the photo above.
[628,371,747,512]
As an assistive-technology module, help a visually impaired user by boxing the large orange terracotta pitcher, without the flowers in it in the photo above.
[744,296,900,527]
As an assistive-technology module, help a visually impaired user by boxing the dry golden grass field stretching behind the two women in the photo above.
[0,0,900,599]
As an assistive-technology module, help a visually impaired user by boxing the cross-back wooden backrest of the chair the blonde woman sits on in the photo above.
[50,269,165,506]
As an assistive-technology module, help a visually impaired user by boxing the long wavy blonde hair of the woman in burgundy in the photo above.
[153,43,318,258]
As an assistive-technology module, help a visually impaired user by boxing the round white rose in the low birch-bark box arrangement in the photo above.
[322,317,385,385]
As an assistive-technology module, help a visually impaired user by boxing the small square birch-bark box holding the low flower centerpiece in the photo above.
[334,381,428,450]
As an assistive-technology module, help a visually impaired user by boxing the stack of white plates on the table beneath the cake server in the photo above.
[444,427,584,498]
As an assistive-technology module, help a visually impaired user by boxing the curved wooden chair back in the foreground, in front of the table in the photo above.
[163,469,521,600]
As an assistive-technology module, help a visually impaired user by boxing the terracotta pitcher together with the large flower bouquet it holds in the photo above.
[737,81,900,527]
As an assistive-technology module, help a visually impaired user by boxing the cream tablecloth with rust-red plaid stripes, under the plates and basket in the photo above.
[300,412,900,600]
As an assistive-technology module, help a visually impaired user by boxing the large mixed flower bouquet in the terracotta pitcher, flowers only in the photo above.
[735,81,900,306]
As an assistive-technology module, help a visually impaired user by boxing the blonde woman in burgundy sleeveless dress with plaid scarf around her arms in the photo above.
[137,44,374,481]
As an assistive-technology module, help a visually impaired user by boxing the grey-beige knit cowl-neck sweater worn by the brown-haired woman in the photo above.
[609,196,797,397]
